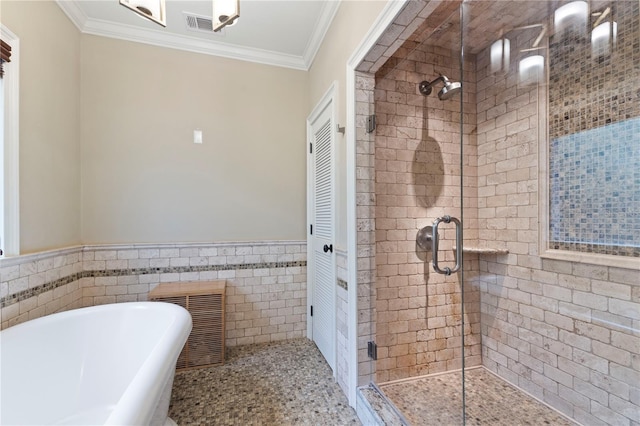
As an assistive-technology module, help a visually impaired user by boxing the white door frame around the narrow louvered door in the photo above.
[305,81,338,378]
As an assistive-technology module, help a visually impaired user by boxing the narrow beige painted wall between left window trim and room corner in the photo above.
[0,0,80,253]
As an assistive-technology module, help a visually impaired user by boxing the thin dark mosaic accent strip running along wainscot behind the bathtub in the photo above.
[0,261,307,308]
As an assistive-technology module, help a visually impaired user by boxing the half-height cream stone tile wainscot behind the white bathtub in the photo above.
[0,242,307,346]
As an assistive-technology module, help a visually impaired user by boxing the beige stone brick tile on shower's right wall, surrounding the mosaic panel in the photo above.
[477,11,640,425]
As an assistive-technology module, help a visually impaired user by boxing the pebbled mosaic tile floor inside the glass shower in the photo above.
[380,368,575,426]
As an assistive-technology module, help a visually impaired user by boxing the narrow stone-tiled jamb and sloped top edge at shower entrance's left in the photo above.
[355,0,468,385]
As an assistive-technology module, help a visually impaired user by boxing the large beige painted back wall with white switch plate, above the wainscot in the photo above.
[81,35,309,243]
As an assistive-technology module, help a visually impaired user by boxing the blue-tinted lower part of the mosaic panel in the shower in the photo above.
[549,117,640,255]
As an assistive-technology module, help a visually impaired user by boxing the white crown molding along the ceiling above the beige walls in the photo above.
[55,0,340,71]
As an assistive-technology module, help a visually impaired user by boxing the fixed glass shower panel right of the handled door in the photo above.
[461,0,640,425]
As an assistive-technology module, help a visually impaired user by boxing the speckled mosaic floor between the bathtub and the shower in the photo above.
[169,339,360,426]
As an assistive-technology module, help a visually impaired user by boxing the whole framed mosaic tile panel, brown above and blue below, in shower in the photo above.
[549,1,640,257]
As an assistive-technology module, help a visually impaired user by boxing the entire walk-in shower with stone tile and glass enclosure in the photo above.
[356,0,640,425]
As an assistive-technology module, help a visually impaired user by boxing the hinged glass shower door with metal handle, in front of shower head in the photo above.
[371,2,468,424]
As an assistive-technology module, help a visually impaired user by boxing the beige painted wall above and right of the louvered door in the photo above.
[309,0,387,249]
